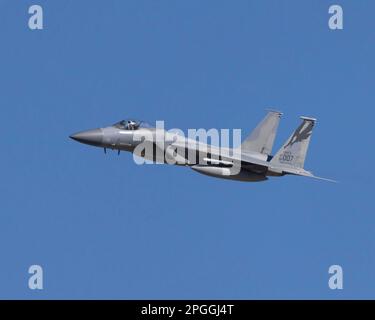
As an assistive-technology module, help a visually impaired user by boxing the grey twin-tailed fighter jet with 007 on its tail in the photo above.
[70,110,334,182]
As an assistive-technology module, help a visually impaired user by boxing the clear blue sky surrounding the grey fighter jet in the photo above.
[0,0,375,299]
